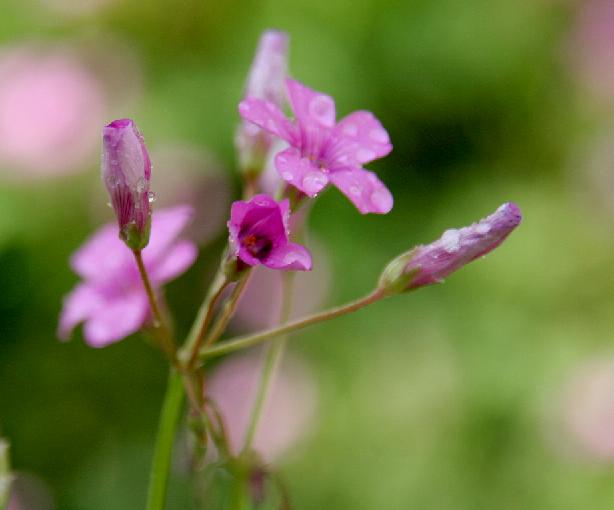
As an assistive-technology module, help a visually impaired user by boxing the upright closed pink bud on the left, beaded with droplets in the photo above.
[101,119,153,250]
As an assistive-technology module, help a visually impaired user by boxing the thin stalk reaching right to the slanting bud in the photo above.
[200,289,385,361]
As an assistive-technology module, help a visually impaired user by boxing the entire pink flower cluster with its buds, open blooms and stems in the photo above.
[58,31,521,508]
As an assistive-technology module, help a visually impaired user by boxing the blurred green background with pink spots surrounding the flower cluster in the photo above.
[0,0,614,510]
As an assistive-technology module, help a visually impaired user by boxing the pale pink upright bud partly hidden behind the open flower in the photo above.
[235,30,288,172]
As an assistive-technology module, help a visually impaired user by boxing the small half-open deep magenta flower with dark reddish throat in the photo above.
[228,195,311,271]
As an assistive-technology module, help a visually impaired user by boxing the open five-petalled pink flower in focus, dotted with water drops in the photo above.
[239,80,393,214]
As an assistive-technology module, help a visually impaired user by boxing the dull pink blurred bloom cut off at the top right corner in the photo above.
[570,0,614,105]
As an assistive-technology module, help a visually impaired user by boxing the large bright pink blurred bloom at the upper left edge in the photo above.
[0,46,106,176]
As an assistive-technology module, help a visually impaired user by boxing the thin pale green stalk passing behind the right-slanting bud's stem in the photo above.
[241,273,294,454]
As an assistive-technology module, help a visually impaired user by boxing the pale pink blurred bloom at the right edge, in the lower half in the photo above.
[561,356,614,461]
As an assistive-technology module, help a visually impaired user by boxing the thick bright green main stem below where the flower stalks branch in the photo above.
[147,369,184,510]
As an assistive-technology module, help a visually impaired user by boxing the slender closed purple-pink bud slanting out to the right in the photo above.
[379,202,522,294]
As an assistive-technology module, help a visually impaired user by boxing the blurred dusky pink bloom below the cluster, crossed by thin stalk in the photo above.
[207,352,316,462]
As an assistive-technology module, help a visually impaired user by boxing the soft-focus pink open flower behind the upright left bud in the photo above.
[58,206,197,347]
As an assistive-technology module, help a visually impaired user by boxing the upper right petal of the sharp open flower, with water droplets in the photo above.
[327,111,392,170]
